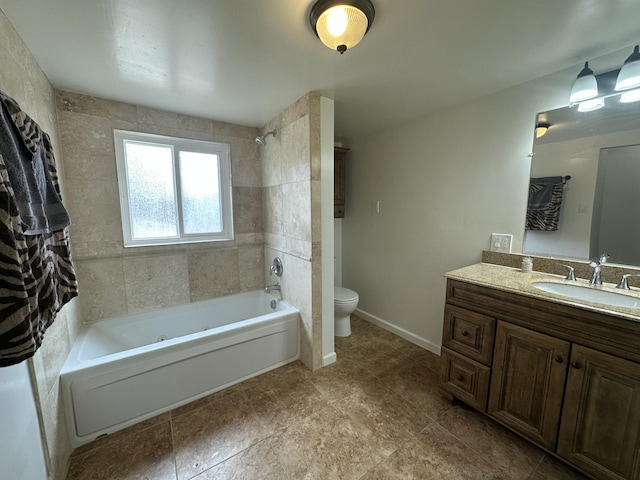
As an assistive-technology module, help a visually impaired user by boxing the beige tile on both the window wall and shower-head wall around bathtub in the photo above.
[57,91,322,368]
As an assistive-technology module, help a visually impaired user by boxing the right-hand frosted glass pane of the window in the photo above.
[180,152,222,234]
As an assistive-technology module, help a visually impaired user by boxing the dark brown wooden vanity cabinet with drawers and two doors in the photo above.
[441,279,640,480]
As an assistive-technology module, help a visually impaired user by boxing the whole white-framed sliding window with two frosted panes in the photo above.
[114,130,233,247]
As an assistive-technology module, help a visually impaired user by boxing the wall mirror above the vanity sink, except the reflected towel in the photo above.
[522,96,640,266]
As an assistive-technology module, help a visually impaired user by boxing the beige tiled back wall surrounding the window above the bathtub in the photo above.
[57,91,264,322]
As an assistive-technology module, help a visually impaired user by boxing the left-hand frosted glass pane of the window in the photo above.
[125,142,178,239]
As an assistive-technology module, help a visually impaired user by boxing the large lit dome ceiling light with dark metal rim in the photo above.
[309,0,375,54]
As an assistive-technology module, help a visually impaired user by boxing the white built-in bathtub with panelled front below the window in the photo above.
[60,291,300,447]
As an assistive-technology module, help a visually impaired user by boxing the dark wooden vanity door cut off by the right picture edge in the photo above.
[557,345,640,480]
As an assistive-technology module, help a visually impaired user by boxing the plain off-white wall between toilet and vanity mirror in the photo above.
[342,45,626,352]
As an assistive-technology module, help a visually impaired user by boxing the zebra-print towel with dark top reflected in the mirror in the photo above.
[525,177,564,231]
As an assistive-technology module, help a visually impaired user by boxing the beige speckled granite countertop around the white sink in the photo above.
[445,263,640,322]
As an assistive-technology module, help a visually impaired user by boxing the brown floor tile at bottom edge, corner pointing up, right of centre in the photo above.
[362,423,504,480]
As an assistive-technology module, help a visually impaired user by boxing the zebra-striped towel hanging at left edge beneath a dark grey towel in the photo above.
[0,92,78,367]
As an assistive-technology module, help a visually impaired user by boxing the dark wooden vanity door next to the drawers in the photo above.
[488,321,571,450]
